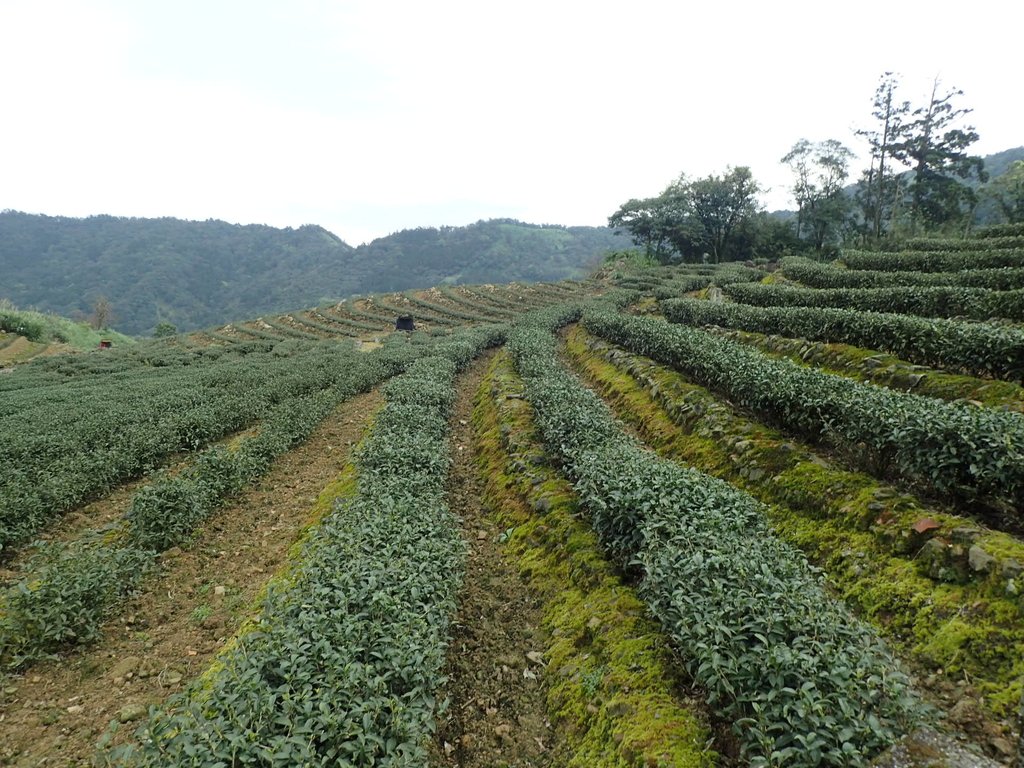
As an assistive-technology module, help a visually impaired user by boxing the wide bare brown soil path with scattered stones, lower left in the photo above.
[0,390,382,766]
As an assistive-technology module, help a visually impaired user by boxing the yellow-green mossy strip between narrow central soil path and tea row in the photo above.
[473,353,715,768]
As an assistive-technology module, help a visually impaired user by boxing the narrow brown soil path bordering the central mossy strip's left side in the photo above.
[437,355,555,768]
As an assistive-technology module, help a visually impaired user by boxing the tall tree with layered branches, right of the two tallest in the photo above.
[892,78,987,229]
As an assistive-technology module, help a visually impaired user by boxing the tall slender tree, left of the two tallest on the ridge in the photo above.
[855,72,910,241]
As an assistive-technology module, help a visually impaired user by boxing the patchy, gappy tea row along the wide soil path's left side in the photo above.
[0,345,417,668]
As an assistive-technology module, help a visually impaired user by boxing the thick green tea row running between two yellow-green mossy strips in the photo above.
[509,311,923,766]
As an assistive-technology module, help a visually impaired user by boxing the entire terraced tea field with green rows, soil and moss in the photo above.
[0,247,1024,768]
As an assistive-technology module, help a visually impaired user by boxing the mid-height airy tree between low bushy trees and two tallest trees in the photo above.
[781,138,853,253]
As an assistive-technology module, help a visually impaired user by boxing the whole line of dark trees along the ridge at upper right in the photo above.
[608,72,1024,263]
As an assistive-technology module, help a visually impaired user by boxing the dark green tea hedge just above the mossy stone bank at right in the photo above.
[585,313,1024,517]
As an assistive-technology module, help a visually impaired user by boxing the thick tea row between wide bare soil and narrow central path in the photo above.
[121,329,502,768]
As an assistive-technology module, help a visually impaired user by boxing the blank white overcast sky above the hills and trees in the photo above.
[0,0,1024,245]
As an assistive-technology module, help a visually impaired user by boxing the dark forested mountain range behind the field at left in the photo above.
[0,211,629,335]
